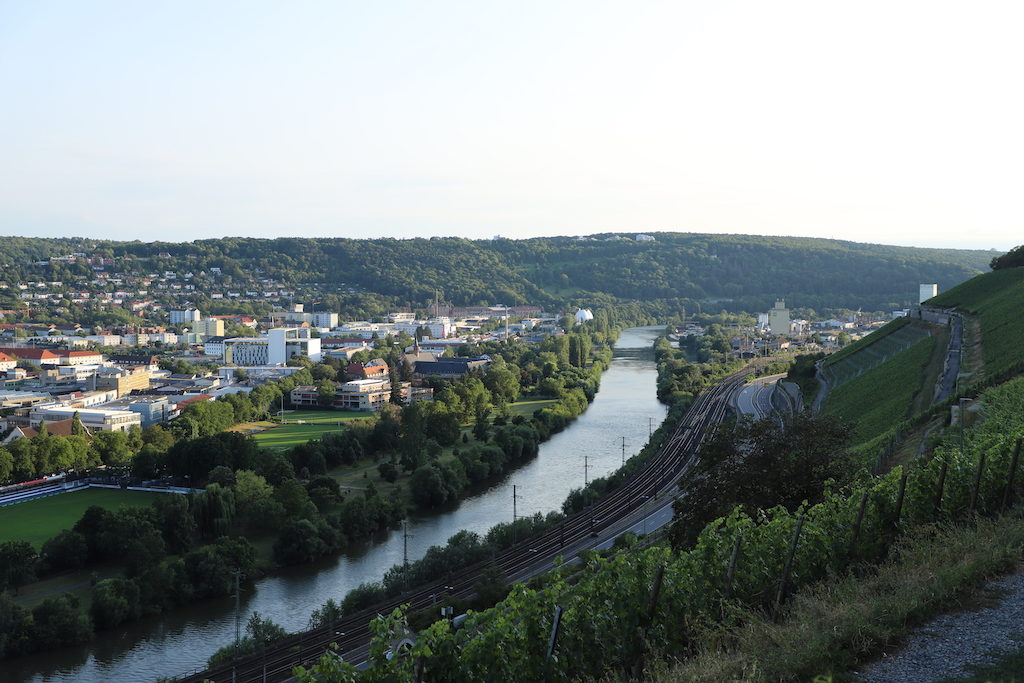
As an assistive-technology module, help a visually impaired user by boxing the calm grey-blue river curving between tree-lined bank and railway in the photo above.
[8,327,666,683]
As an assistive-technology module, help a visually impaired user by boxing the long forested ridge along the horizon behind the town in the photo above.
[0,232,992,310]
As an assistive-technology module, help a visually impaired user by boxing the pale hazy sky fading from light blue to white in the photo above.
[0,0,1024,250]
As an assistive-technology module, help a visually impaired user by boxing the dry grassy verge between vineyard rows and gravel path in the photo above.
[650,512,1024,682]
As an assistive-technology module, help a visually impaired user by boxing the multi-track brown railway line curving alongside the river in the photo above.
[180,368,751,683]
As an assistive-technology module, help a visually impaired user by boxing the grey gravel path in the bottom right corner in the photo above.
[855,569,1024,683]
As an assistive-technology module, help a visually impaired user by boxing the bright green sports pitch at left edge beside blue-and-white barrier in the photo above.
[0,488,169,550]
